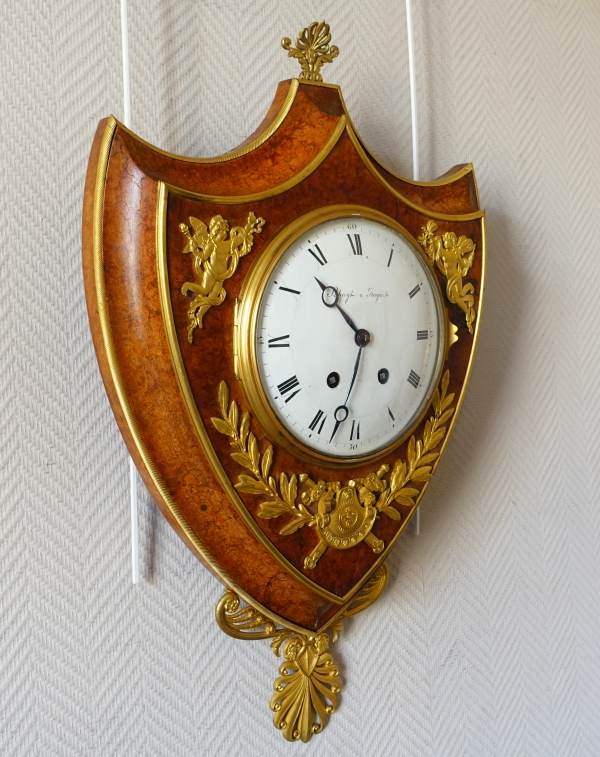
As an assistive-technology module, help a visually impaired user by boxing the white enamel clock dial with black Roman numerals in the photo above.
[255,215,443,458]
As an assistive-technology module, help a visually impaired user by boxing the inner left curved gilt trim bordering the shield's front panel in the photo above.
[156,182,345,604]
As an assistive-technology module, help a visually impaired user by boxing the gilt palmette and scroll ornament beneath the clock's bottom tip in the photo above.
[215,564,388,742]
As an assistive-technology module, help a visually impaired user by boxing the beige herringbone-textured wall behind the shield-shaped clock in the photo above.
[0,0,600,757]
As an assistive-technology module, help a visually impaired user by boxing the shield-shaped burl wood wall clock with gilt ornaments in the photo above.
[83,22,485,741]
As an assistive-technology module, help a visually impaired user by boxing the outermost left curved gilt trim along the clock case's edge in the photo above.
[92,117,322,633]
